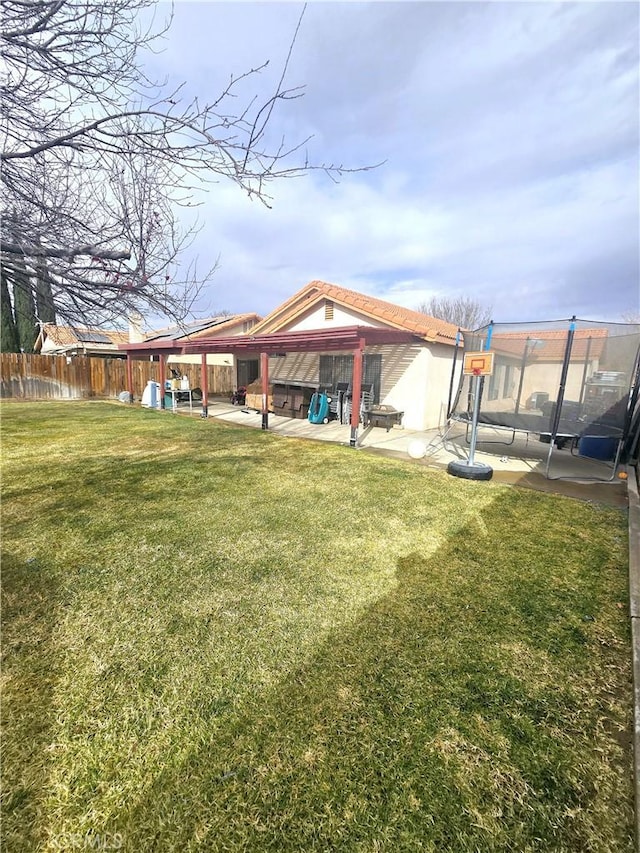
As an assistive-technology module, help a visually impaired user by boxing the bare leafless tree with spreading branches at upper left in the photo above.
[0,0,370,322]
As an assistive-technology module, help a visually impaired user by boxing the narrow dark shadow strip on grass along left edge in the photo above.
[2,551,60,851]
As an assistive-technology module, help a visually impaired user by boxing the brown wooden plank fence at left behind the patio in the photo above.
[0,352,233,400]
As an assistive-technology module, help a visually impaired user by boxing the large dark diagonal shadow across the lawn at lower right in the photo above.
[113,492,633,853]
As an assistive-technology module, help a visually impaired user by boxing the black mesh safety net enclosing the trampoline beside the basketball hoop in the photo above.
[449,318,640,462]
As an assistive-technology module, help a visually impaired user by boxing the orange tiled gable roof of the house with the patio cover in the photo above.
[251,281,458,344]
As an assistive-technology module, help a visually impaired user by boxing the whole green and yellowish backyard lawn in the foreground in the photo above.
[2,403,633,853]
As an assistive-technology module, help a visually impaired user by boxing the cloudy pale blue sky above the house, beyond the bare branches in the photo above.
[149,0,640,322]
